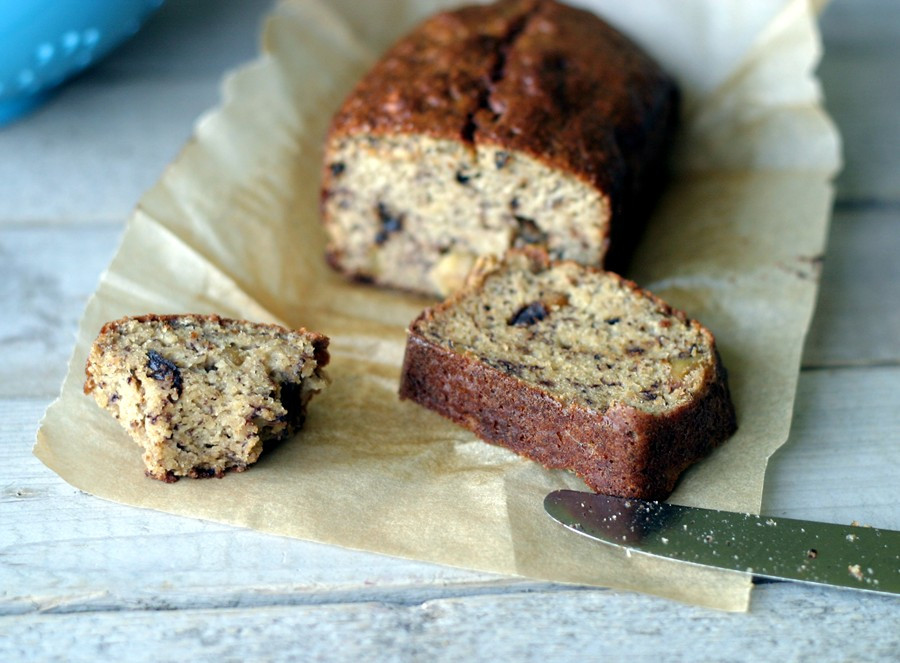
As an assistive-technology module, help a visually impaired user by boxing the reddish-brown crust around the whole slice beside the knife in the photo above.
[400,252,736,499]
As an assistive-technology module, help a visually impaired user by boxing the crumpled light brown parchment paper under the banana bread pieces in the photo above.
[35,0,839,610]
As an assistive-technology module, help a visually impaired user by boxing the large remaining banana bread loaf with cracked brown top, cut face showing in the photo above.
[321,0,678,294]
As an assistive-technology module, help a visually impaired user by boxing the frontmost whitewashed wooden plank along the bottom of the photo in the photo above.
[0,585,900,663]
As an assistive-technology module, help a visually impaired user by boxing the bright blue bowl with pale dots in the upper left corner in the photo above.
[0,0,163,126]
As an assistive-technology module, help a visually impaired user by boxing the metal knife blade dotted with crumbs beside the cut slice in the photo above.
[544,490,900,594]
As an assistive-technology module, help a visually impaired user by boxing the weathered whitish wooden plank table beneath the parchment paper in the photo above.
[0,0,900,661]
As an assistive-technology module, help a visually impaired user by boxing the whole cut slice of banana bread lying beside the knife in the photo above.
[400,251,736,499]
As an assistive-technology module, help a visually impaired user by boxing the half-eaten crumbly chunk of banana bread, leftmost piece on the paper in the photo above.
[84,315,328,482]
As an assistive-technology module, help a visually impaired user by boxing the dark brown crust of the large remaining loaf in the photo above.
[322,0,678,289]
